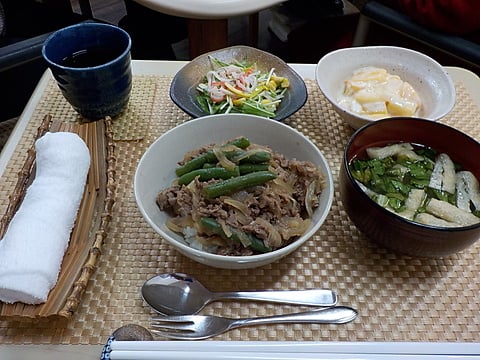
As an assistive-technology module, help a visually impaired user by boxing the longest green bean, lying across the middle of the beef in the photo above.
[203,171,277,199]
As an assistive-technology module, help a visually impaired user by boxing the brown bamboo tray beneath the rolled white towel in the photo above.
[0,115,115,319]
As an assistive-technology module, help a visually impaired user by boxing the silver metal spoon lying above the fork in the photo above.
[142,273,337,315]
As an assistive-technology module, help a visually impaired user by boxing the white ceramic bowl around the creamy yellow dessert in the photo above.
[315,46,456,129]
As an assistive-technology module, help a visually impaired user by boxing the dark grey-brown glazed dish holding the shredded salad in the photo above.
[170,46,307,121]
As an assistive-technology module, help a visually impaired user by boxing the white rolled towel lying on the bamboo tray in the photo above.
[0,132,90,304]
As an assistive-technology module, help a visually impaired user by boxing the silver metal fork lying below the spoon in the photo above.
[151,306,358,340]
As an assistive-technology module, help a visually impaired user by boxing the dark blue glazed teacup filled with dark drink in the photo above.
[42,22,132,121]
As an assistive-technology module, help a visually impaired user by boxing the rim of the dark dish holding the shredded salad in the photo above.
[169,45,308,121]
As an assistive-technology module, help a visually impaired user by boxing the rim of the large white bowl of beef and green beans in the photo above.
[133,114,335,266]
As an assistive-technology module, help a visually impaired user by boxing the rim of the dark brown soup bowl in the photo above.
[342,117,480,233]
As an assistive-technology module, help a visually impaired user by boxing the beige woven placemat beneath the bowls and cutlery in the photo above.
[0,72,480,344]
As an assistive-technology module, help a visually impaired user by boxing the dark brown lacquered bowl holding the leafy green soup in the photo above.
[339,118,480,257]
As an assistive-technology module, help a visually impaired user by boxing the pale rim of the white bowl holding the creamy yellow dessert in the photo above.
[315,45,457,123]
